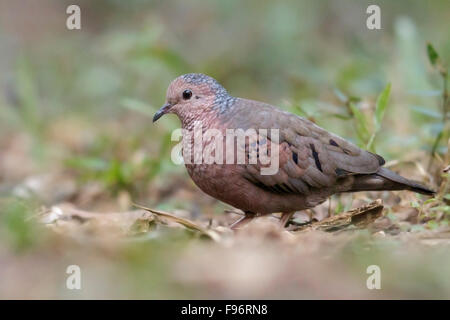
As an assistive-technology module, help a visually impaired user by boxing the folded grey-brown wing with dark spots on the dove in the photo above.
[228,99,384,194]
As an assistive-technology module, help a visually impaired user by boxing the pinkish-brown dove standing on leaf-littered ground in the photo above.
[153,73,434,229]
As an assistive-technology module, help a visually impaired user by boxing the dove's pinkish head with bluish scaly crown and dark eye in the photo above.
[153,73,234,122]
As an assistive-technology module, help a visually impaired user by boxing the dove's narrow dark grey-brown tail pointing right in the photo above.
[349,167,435,196]
